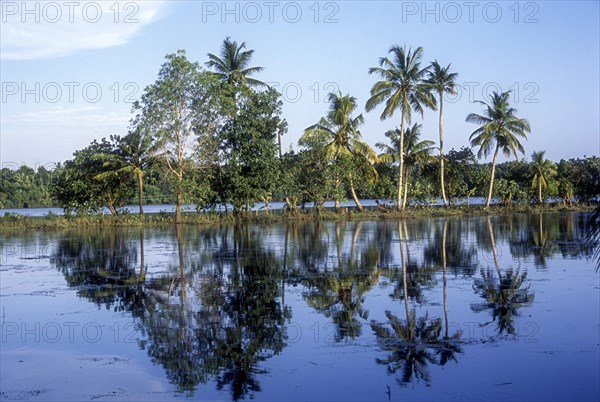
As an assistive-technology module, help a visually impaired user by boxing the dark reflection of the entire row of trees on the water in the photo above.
[32,214,588,400]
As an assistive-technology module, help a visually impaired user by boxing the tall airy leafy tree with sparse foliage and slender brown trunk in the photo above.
[133,50,216,223]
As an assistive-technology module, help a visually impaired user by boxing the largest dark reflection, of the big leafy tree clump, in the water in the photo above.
[139,226,290,400]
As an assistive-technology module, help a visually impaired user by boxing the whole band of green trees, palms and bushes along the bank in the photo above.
[0,38,600,217]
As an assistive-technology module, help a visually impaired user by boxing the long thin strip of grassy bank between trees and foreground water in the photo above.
[0,204,595,230]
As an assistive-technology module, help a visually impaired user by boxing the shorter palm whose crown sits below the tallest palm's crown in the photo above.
[375,123,434,208]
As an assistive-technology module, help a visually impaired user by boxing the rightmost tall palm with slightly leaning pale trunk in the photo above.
[466,91,531,207]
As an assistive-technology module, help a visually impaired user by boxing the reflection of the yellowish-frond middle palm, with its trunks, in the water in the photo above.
[303,222,379,341]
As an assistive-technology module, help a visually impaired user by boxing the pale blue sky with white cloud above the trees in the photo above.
[0,0,600,168]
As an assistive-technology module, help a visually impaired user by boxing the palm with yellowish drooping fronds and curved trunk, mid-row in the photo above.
[300,91,378,211]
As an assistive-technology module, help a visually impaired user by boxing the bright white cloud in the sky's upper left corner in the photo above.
[0,1,168,60]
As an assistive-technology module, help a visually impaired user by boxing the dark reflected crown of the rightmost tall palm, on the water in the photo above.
[471,269,533,335]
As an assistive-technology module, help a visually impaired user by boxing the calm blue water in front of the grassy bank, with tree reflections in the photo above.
[0,213,600,401]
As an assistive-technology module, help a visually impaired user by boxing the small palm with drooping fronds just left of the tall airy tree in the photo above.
[94,130,162,216]
